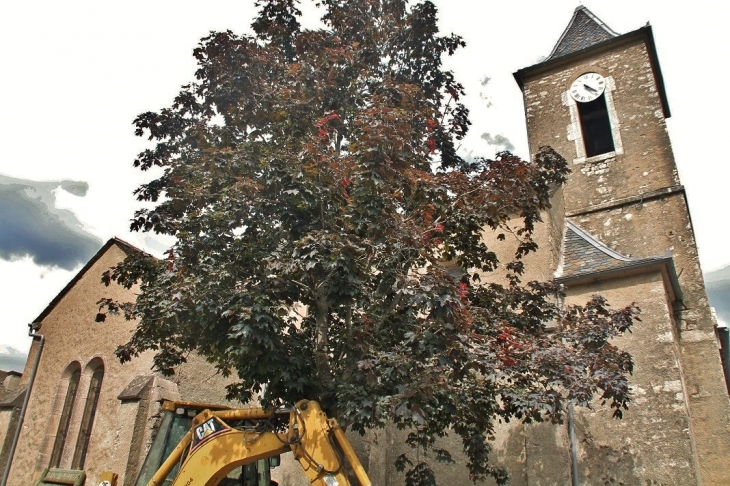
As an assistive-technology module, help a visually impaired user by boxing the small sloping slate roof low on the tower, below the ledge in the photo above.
[556,220,682,301]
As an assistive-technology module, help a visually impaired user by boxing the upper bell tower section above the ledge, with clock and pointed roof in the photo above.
[515,6,683,213]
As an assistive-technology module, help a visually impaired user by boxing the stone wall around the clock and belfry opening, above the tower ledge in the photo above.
[524,39,679,213]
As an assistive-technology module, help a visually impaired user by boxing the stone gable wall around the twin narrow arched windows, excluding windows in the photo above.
[8,246,159,486]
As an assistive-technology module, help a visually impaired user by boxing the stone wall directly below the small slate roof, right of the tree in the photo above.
[566,272,698,485]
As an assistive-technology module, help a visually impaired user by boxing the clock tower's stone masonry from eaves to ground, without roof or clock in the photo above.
[523,28,730,484]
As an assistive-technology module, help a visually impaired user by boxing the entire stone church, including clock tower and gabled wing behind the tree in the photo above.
[0,6,730,486]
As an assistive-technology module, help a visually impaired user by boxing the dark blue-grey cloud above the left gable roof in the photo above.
[0,174,102,270]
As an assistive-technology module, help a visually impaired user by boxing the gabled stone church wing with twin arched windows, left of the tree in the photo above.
[0,238,247,486]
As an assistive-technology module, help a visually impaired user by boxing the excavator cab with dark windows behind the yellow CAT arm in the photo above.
[134,401,281,486]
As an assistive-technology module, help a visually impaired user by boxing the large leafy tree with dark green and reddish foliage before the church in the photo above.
[101,0,637,484]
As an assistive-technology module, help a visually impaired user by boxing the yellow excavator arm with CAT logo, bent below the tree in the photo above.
[148,400,371,486]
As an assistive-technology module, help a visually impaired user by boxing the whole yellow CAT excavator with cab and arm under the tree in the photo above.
[101,400,371,486]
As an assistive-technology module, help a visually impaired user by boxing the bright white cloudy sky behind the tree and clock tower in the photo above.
[0,0,730,351]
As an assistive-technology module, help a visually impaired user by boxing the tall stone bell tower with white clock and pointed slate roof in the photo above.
[514,6,730,485]
